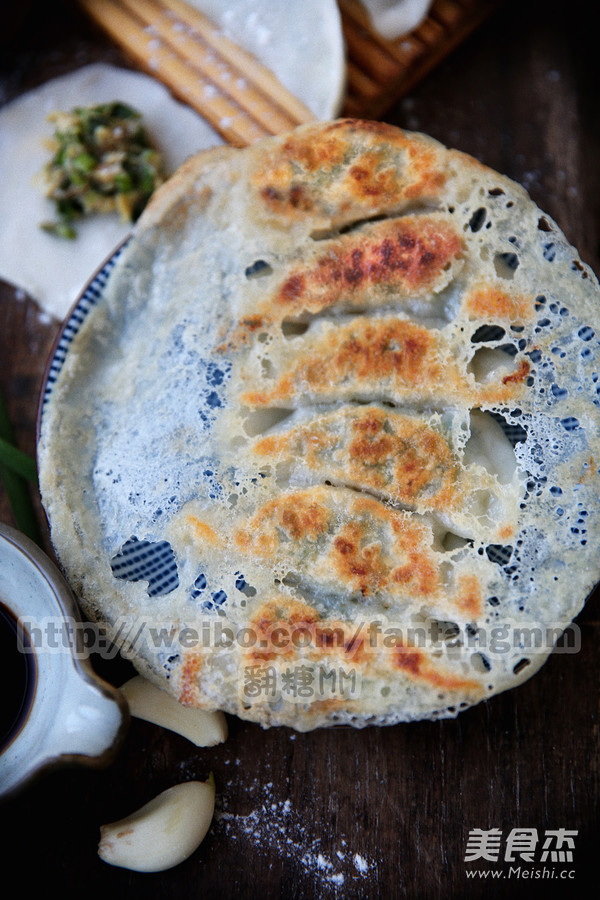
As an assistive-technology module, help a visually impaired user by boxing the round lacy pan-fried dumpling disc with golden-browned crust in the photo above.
[39,120,600,730]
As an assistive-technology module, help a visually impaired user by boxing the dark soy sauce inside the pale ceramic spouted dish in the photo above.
[0,601,37,751]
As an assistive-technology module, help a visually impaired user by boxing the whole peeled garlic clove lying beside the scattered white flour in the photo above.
[98,776,215,872]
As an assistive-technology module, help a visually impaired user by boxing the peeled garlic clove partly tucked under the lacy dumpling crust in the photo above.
[121,675,227,747]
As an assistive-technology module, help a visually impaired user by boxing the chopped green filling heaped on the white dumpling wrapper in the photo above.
[42,101,166,238]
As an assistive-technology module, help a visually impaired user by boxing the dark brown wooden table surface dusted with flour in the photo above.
[0,0,600,900]
